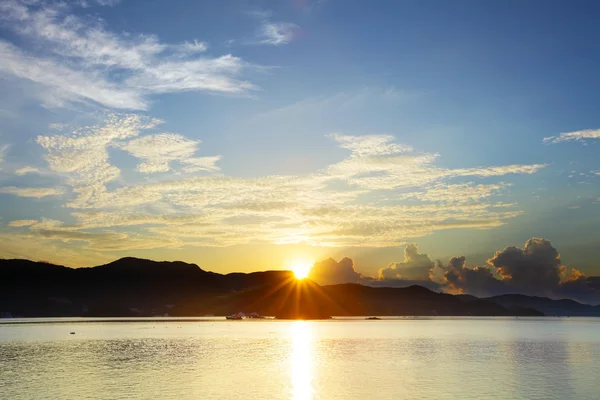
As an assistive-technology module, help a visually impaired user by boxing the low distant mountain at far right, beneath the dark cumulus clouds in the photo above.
[484,294,600,317]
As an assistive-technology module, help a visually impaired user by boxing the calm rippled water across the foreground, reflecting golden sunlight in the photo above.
[0,318,600,400]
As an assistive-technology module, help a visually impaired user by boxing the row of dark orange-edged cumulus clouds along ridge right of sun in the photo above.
[311,238,600,304]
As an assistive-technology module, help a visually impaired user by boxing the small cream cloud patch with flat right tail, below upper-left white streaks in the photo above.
[120,133,221,173]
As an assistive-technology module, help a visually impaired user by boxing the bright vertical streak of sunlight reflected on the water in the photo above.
[291,321,313,400]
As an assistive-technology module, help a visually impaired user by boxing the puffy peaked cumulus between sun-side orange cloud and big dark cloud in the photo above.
[378,244,434,281]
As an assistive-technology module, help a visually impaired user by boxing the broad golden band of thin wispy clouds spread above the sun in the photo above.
[4,115,544,255]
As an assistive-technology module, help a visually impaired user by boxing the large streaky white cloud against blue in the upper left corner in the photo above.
[0,0,256,110]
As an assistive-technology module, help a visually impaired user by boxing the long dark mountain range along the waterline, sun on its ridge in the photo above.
[0,257,600,319]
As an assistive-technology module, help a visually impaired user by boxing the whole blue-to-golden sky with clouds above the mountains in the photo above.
[0,0,600,300]
